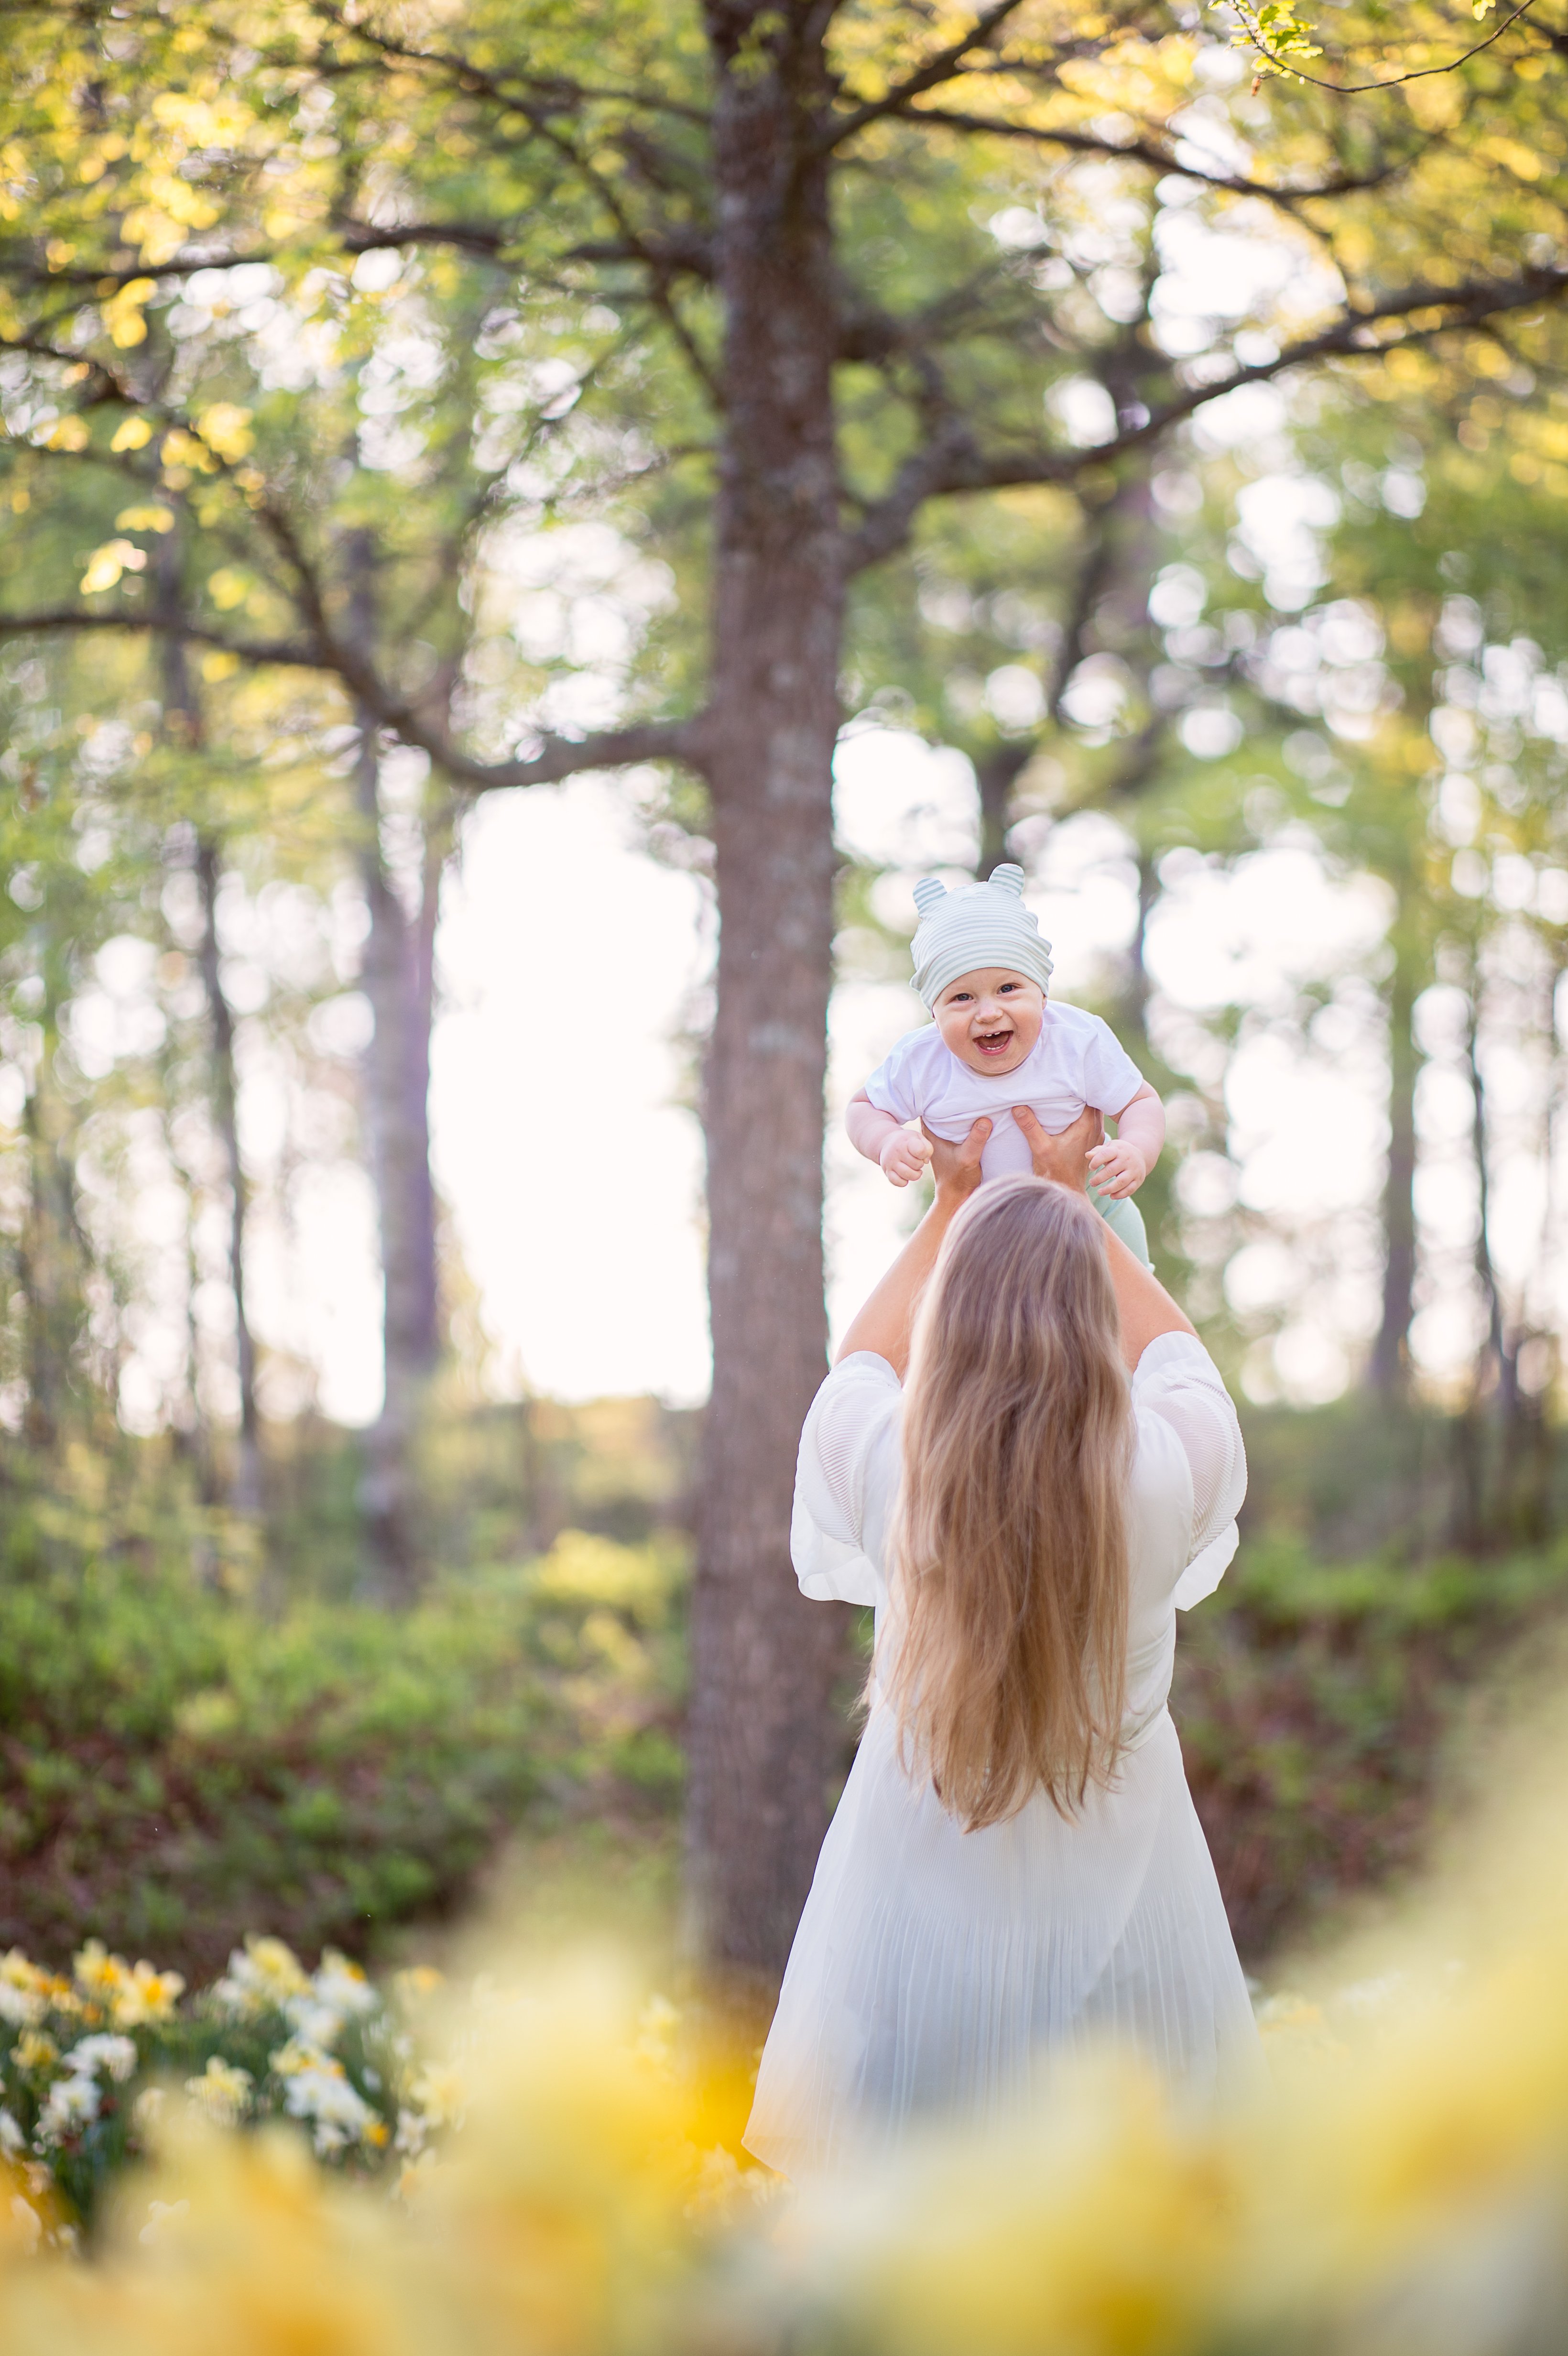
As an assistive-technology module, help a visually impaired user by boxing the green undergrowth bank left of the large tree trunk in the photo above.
[0,1501,683,1977]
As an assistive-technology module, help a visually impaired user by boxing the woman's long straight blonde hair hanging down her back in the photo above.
[876,1178,1132,1831]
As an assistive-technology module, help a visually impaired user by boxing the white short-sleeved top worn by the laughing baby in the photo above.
[866,999,1144,1178]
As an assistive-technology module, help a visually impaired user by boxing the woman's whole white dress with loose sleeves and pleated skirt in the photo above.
[746,1333,1257,2175]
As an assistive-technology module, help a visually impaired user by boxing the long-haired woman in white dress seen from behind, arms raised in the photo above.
[746,1112,1257,2175]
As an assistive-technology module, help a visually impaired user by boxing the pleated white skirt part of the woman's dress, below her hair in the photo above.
[746,1708,1262,2177]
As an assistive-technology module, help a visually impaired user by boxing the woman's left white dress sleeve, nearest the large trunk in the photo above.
[789,1350,904,1604]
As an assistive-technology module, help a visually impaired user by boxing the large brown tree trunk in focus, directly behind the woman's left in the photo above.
[687,0,845,1996]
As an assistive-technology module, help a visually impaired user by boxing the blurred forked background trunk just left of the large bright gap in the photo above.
[356,714,440,1600]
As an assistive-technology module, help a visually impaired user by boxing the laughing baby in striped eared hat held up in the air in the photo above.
[845,867,1165,1265]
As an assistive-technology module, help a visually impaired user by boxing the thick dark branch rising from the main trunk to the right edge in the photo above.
[848,269,1568,573]
